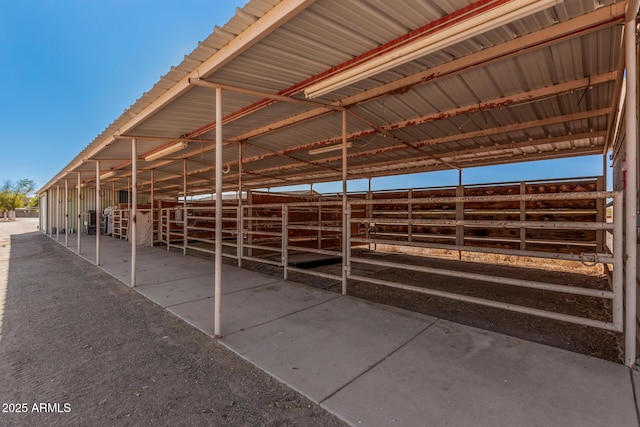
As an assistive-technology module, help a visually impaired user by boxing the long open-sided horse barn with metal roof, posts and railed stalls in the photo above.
[38,0,639,380]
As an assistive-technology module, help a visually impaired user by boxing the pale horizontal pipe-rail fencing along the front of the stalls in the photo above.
[126,187,623,338]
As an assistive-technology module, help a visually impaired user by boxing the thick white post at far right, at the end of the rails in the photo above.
[624,1,638,367]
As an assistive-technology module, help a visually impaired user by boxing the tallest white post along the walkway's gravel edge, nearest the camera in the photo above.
[213,87,222,339]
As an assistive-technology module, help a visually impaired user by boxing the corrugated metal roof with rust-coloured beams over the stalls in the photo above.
[42,0,626,194]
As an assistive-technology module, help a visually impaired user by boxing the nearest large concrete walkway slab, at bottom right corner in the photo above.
[322,320,638,426]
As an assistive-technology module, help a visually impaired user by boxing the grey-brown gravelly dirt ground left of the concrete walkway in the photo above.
[0,220,343,426]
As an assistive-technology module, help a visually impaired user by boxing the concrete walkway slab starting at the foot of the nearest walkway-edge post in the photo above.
[221,298,436,402]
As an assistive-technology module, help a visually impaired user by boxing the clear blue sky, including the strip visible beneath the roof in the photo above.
[0,0,602,191]
